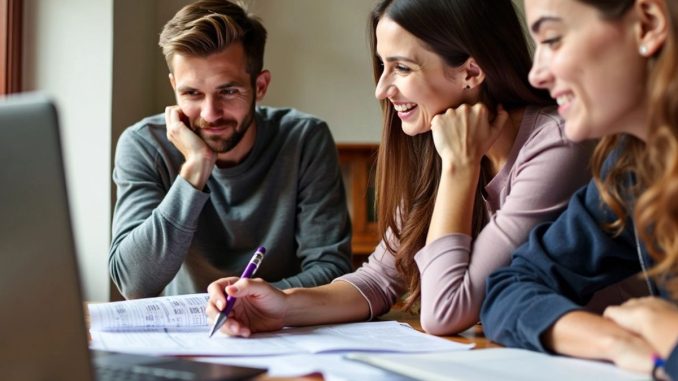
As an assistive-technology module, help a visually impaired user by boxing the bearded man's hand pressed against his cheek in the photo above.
[165,106,217,190]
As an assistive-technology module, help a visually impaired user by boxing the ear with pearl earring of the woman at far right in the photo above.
[634,0,676,57]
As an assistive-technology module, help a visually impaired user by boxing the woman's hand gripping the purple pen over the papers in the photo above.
[206,277,287,337]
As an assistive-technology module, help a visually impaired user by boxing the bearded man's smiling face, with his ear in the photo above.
[170,43,268,153]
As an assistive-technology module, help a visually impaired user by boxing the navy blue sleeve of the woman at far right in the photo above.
[481,181,640,351]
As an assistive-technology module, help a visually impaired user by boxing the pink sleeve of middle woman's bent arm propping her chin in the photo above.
[415,117,591,335]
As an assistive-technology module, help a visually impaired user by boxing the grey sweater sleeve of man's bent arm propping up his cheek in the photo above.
[108,130,209,298]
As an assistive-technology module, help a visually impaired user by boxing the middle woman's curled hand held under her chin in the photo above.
[431,103,508,169]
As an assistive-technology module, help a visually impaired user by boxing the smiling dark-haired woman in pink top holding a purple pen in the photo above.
[208,0,592,336]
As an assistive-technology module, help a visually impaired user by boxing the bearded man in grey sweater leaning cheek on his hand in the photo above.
[109,0,351,298]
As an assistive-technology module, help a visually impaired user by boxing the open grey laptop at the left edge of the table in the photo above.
[0,93,265,381]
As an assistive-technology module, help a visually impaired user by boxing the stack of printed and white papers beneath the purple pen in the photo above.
[89,294,473,356]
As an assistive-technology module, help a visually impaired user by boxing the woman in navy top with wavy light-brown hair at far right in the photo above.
[482,0,678,380]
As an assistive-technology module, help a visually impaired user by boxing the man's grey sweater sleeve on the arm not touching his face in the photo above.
[274,122,351,288]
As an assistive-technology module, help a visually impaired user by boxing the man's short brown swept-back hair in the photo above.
[158,0,266,83]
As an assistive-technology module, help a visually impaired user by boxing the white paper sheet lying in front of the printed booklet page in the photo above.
[90,321,473,356]
